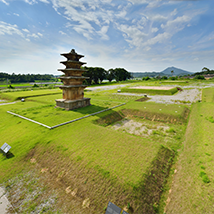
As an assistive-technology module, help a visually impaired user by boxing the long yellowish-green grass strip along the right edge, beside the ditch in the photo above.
[166,88,214,213]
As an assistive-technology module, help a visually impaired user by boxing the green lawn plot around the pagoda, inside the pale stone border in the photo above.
[7,91,124,126]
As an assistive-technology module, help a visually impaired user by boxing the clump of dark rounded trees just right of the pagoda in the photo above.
[82,66,132,85]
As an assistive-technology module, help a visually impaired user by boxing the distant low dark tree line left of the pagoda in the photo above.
[0,73,56,83]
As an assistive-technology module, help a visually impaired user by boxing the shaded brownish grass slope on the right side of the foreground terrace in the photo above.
[134,146,174,214]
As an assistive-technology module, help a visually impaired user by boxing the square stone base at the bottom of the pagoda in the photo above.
[56,98,91,111]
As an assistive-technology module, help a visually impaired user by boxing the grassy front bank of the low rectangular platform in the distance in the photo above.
[121,87,178,95]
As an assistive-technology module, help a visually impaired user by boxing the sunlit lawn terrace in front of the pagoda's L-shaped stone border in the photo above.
[0,92,161,213]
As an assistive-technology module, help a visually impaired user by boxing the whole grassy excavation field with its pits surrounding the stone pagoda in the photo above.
[0,83,214,213]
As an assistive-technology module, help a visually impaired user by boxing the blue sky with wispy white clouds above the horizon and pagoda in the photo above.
[0,0,214,75]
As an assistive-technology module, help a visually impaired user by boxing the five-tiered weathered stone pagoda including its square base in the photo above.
[56,49,91,110]
